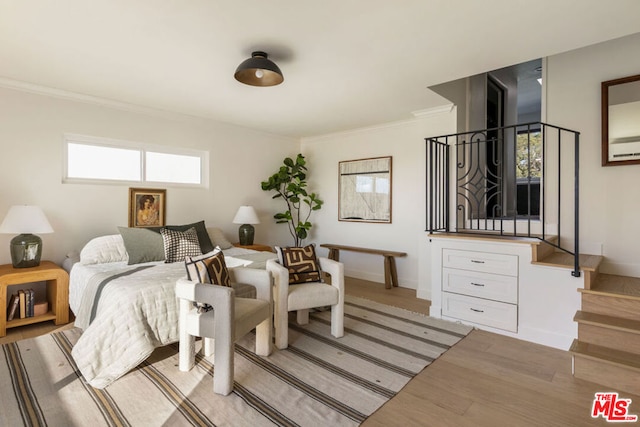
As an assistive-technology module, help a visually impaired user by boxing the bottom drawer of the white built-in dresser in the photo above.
[442,292,518,332]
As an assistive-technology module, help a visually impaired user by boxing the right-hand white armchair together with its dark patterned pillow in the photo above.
[267,245,344,349]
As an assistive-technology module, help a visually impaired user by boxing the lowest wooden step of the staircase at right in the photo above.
[569,340,640,394]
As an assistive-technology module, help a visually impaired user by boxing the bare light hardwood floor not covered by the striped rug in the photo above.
[0,278,640,427]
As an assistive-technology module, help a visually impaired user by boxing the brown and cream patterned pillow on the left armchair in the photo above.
[184,247,231,313]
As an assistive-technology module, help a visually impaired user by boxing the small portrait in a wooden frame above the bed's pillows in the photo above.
[129,188,167,227]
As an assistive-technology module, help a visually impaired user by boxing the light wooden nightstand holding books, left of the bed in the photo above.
[0,261,69,337]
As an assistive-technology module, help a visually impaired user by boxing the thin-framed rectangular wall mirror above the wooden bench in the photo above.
[338,156,391,223]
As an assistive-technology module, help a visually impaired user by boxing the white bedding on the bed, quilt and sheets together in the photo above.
[69,248,276,388]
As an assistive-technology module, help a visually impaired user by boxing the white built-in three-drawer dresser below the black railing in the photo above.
[441,248,518,332]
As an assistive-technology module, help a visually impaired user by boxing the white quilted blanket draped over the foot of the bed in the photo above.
[72,263,185,388]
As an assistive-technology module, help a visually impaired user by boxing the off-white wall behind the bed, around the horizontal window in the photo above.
[0,88,299,264]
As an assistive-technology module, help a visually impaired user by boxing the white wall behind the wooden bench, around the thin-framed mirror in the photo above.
[301,107,456,289]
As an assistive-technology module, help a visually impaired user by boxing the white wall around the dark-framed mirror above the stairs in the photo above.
[545,34,640,277]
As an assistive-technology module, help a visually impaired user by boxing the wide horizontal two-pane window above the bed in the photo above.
[63,134,209,187]
